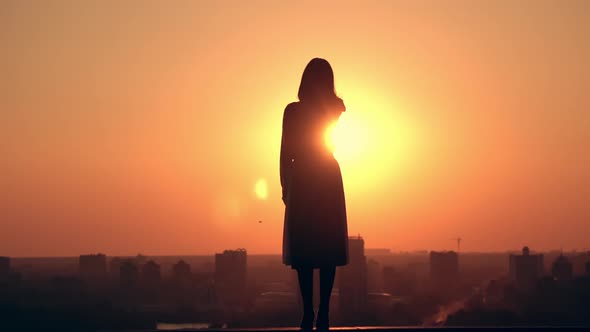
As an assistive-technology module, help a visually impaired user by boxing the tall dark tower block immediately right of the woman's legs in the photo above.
[337,235,368,324]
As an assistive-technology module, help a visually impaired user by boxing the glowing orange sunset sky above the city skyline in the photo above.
[0,0,590,256]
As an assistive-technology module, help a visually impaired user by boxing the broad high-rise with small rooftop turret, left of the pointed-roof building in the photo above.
[509,247,543,290]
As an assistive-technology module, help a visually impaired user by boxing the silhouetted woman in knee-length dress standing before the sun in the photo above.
[280,58,348,330]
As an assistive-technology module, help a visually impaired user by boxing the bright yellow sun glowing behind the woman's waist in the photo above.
[324,91,420,195]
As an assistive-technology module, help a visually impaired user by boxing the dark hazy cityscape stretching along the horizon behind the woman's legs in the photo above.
[0,236,590,330]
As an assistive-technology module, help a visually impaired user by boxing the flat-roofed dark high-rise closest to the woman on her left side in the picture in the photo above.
[214,249,247,306]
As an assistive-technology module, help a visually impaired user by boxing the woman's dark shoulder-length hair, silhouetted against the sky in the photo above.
[297,58,344,112]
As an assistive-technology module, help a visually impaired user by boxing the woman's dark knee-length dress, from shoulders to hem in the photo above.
[280,100,348,268]
